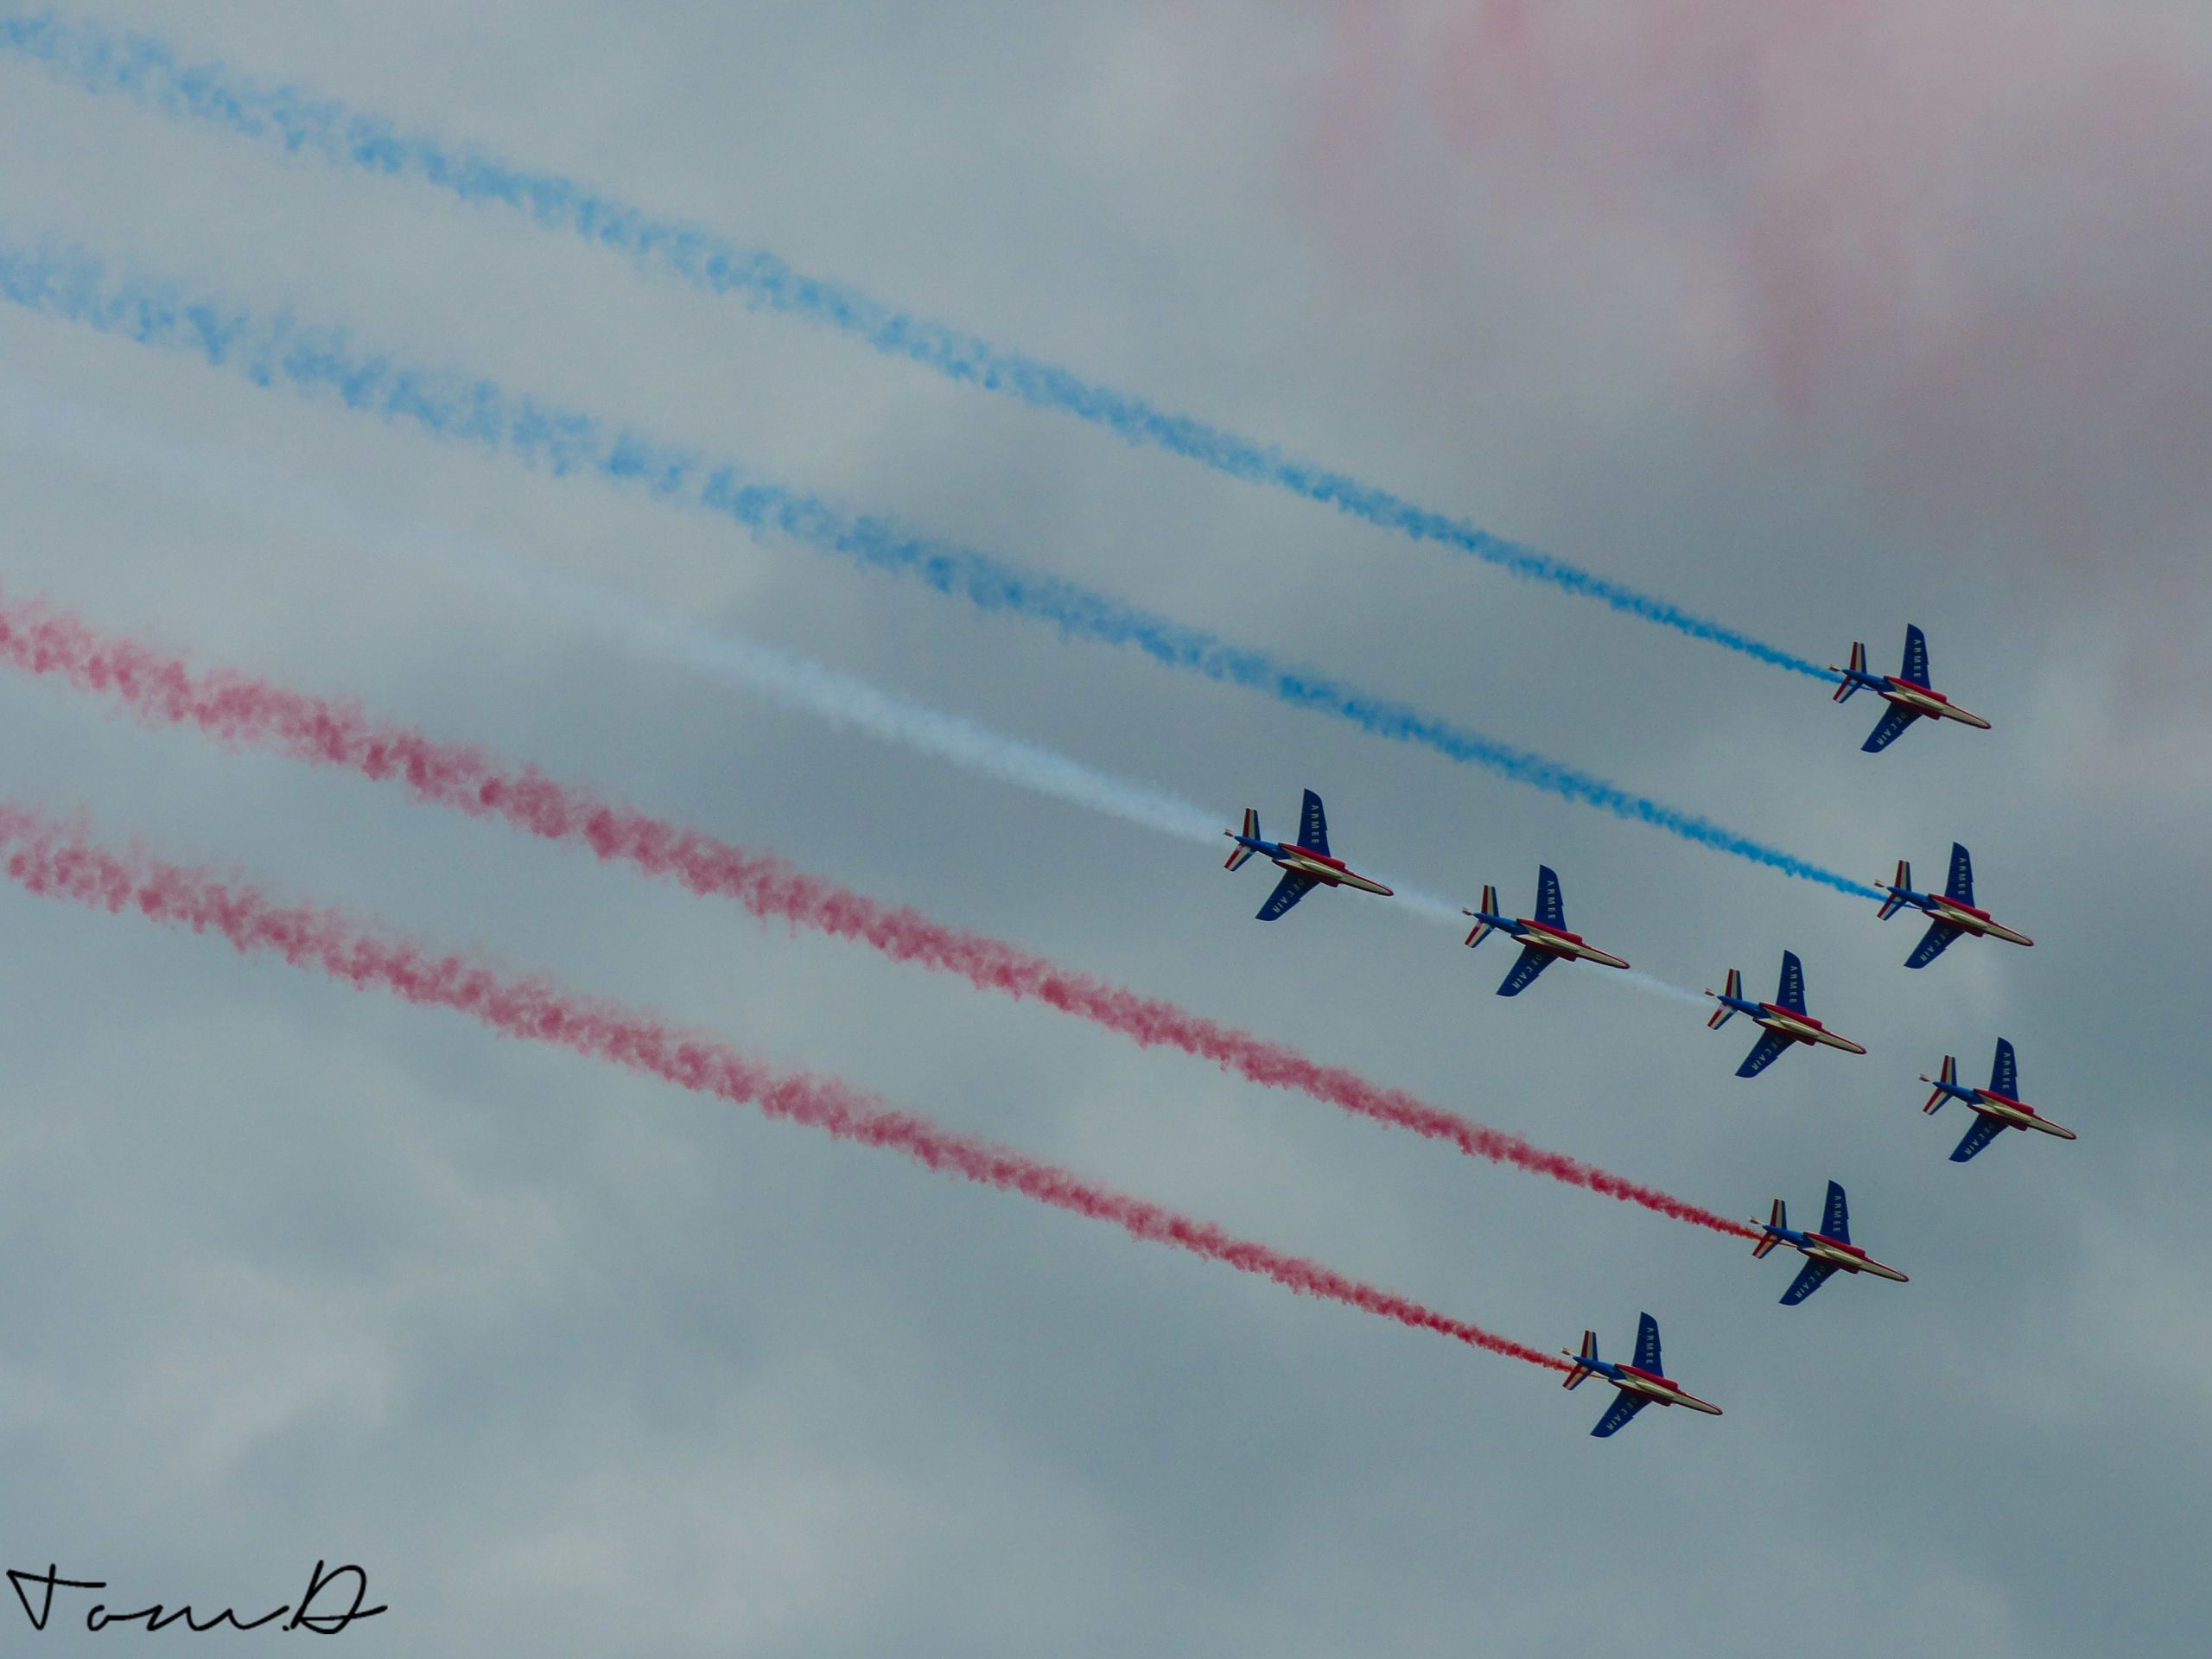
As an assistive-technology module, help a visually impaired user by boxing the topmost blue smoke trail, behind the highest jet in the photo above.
[0,13,1836,681]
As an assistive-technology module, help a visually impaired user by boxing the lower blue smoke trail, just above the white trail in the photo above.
[0,237,1883,898]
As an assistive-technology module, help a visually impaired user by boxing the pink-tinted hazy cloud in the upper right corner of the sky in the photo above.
[1300,0,2212,564]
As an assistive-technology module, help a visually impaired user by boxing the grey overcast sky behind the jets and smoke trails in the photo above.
[0,0,2212,1659]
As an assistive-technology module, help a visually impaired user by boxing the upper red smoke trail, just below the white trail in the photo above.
[0,601,1758,1239]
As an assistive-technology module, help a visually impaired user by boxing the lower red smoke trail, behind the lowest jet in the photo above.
[0,807,1568,1371]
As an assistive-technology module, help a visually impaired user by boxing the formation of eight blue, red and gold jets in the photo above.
[1224,626,2044,1438]
